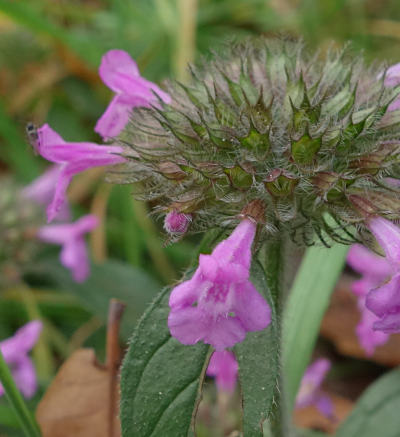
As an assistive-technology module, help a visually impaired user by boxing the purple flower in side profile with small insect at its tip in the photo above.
[36,124,125,222]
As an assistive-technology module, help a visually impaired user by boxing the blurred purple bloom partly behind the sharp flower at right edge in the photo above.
[347,244,393,356]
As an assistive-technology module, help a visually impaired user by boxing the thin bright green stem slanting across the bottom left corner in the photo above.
[0,351,41,437]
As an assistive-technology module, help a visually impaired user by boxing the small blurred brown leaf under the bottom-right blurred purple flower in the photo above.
[293,393,353,434]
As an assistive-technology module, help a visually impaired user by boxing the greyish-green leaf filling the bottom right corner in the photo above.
[335,369,400,437]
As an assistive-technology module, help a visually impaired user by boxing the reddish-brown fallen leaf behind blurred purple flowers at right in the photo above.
[321,275,400,367]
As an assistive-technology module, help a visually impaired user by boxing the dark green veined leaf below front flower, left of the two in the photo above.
[121,289,210,437]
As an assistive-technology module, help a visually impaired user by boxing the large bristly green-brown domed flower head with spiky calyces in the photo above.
[110,40,400,244]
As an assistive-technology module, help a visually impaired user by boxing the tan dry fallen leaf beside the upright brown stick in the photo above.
[36,349,120,437]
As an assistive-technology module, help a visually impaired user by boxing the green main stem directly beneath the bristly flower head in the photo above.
[260,239,291,437]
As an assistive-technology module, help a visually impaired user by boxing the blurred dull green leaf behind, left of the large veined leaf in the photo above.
[30,260,161,339]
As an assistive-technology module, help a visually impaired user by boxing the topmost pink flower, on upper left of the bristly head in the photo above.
[94,50,171,139]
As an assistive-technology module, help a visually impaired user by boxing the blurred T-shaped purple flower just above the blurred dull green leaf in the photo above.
[37,215,98,282]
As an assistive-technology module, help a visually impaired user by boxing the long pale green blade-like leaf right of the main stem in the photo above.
[283,244,348,407]
